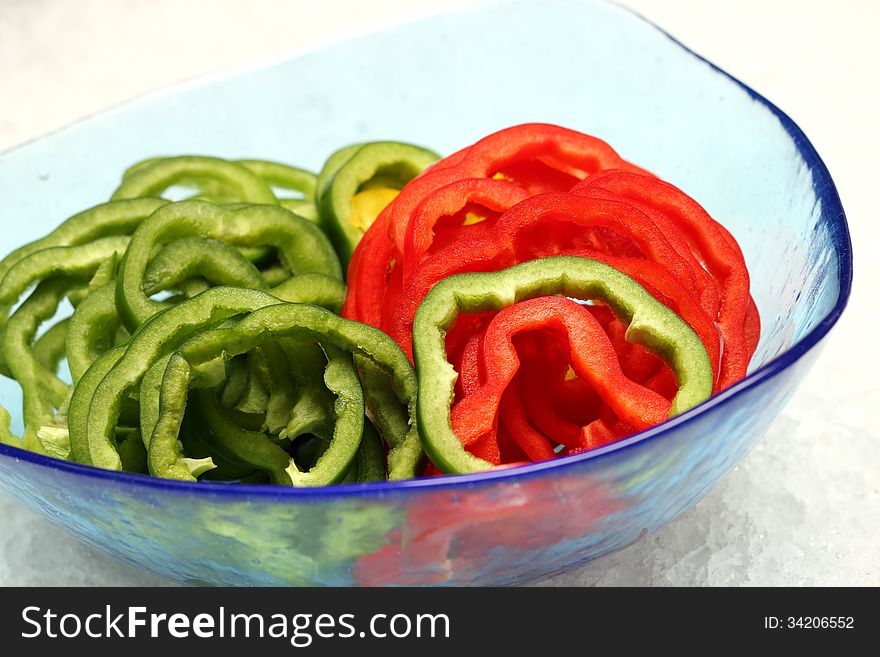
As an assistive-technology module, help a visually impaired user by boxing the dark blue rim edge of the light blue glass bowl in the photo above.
[0,5,853,502]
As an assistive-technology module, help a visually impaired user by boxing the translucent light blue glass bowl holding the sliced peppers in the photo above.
[0,1,852,585]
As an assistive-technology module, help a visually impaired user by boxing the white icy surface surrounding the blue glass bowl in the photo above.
[0,0,880,586]
